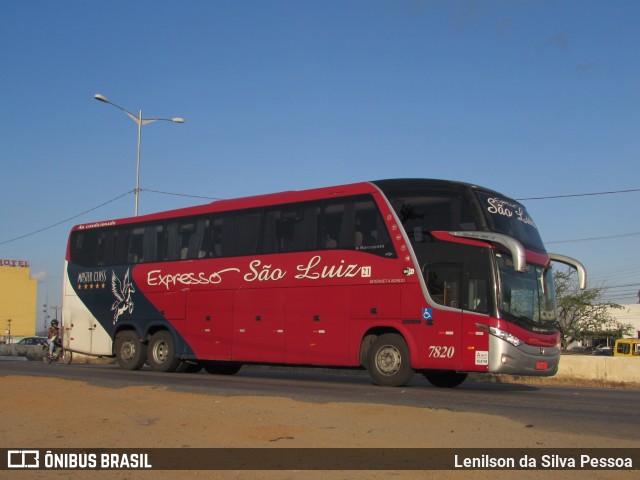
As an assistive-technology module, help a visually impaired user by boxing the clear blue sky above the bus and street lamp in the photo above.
[0,0,640,323]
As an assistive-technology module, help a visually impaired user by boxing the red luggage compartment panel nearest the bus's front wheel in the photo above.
[285,287,349,365]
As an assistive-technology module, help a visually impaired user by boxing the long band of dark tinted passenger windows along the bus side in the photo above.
[71,196,396,267]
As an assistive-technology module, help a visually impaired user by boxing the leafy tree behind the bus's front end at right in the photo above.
[554,270,633,347]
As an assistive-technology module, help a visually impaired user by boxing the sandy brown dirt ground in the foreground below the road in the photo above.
[0,376,638,480]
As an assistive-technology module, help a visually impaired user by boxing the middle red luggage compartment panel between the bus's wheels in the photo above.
[232,288,286,363]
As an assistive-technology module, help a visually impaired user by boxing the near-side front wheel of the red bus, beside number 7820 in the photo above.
[368,333,414,387]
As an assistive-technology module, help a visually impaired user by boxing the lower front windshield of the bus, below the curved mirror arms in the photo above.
[496,253,556,329]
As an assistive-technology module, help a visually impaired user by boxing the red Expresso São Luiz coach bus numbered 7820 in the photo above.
[62,179,585,387]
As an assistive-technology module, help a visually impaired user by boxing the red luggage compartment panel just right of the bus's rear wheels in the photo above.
[186,290,234,360]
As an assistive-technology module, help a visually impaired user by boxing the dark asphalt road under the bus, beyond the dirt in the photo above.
[0,360,640,440]
